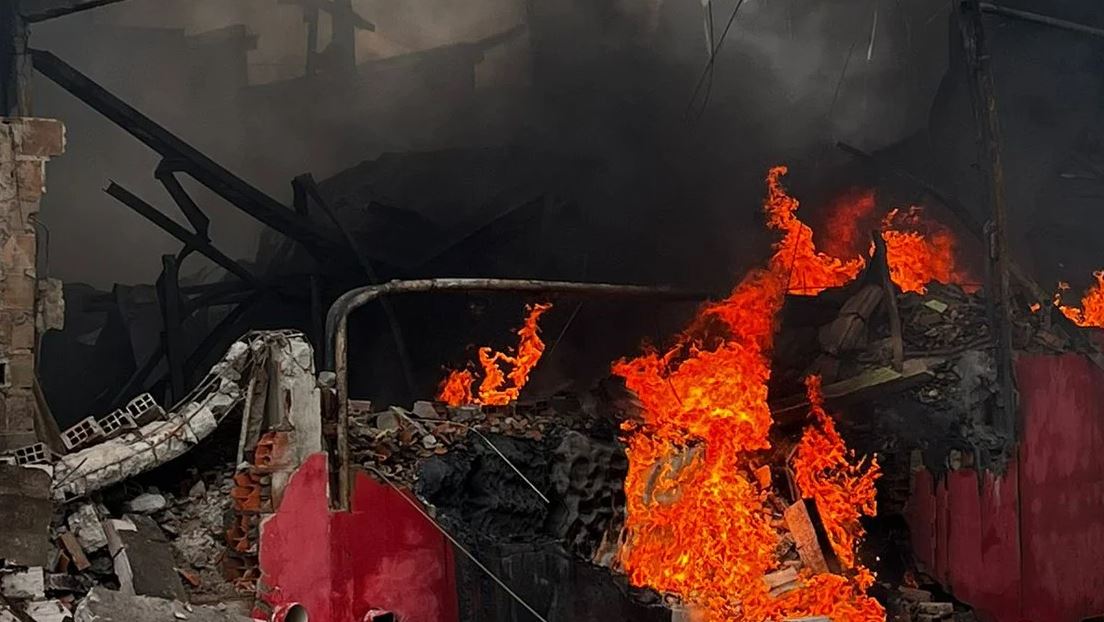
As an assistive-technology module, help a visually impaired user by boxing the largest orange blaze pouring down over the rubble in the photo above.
[613,167,885,622]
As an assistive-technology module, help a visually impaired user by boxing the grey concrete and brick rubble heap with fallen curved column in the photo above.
[0,331,320,622]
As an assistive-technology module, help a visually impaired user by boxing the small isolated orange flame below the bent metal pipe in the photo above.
[437,304,552,405]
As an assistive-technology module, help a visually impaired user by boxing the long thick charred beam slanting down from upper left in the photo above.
[30,50,349,264]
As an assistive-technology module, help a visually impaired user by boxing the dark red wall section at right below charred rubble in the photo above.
[907,355,1104,622]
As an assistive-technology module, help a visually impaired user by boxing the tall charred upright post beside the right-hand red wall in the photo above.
[958,0,1016,436]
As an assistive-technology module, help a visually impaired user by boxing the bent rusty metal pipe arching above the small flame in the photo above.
[326,278,710,509]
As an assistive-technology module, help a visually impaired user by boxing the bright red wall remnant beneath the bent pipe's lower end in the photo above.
[259,454,459,622]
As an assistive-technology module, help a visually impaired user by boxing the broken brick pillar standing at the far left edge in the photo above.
[0,117,65,451]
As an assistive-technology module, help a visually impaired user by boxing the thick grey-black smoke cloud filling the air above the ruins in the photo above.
[33,0,946,286]
